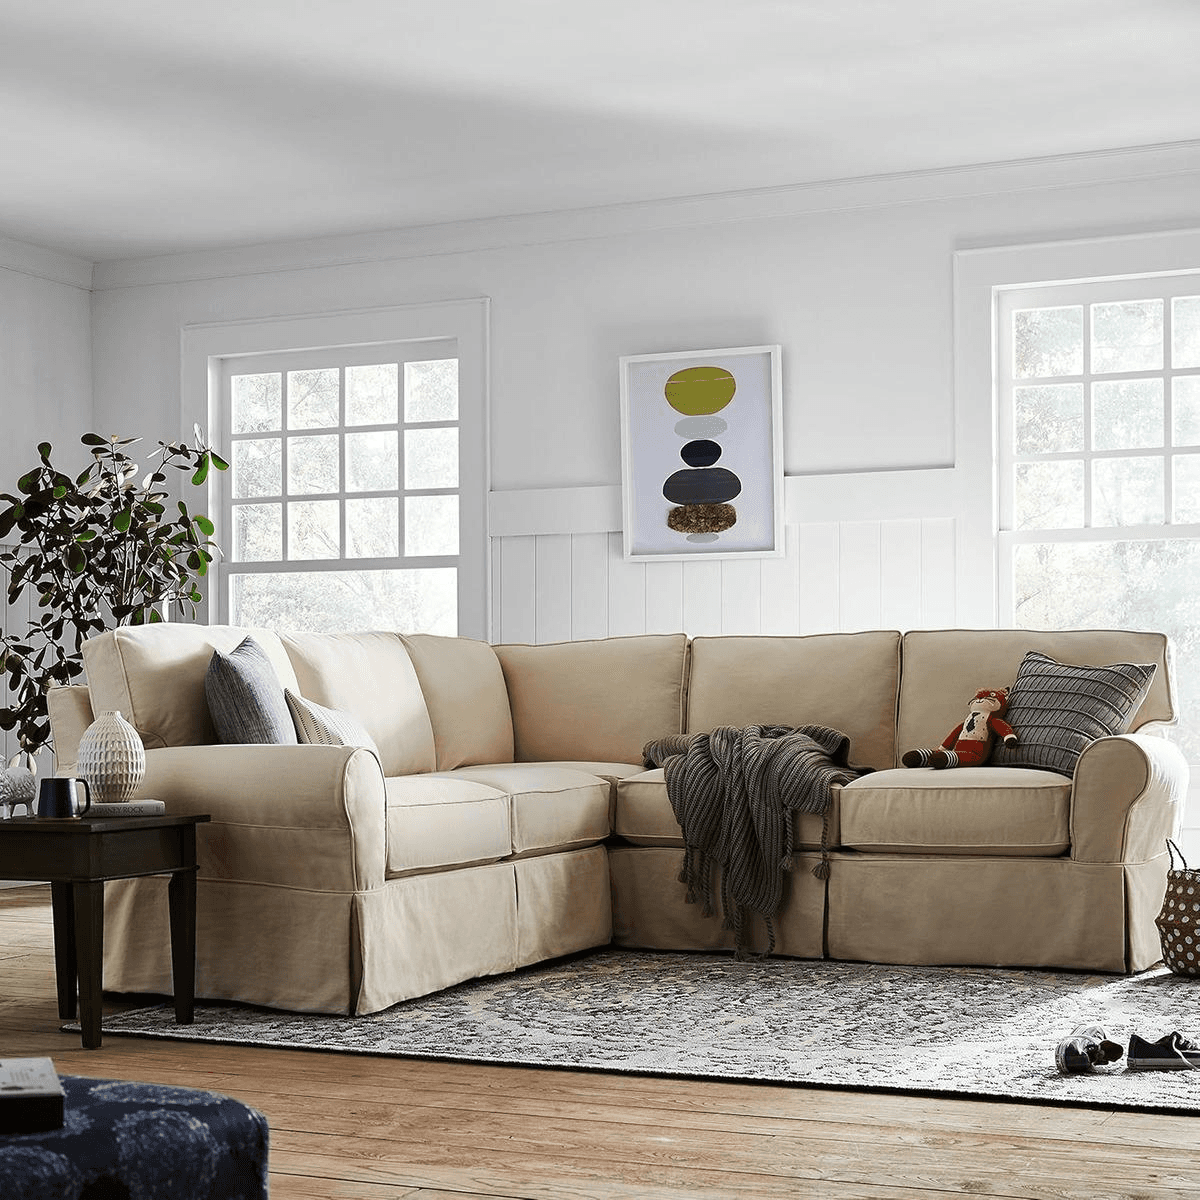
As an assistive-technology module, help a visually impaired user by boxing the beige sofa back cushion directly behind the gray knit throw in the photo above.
[686,630,900,768]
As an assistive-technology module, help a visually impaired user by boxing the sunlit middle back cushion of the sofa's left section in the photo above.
[282,632,434,778]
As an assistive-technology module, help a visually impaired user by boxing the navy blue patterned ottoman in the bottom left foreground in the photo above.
[0,1075,268,1200]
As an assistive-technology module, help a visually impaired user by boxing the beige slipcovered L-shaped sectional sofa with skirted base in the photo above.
[50,625,1187,1013]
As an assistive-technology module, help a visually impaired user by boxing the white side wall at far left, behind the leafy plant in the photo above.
[0,239,91,758]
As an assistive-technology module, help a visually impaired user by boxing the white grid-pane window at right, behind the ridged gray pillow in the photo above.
[995,274,1200,763]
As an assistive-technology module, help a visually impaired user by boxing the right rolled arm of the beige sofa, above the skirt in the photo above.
[1070,733,1188,863]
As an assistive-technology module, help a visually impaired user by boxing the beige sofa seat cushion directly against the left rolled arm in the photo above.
[384,775,512,878]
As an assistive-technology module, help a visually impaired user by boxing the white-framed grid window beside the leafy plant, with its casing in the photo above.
[182,299,488,638]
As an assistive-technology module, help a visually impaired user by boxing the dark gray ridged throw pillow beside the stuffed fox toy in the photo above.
[991,650,1156,775]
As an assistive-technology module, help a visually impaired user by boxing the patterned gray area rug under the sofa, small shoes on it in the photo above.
[88,950,1200,1112]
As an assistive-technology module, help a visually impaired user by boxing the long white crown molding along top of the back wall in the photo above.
[92,142,1200,292]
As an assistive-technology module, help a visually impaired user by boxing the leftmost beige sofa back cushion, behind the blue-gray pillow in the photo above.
[83,622,296,750]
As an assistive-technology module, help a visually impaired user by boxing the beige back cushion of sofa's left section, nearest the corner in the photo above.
[404,634,512,770]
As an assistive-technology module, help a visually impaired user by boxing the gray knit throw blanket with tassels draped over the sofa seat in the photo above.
[642,725,871,959]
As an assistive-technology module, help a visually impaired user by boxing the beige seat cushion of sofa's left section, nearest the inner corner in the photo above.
[441,762,612,856]
